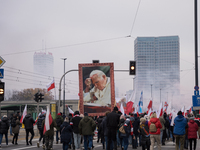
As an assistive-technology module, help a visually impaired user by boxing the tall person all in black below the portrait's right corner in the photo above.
[106,106,120,150]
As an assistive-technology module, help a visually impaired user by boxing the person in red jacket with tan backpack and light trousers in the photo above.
[148,112,162,150]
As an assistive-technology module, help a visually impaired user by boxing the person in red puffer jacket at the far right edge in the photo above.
[188,117,199,150]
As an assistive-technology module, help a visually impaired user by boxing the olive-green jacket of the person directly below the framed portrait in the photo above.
[78,116,96,135]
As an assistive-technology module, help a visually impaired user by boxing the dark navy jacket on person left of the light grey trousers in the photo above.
[60,121,72,143]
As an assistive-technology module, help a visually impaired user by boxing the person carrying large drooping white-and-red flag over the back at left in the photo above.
[42,106,57,150]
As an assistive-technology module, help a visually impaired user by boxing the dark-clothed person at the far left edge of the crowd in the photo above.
[0,115,9,147]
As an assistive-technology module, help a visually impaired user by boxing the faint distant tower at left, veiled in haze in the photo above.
[33,52,54,86]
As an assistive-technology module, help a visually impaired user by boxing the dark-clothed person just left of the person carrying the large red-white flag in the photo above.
[37,111,46,148]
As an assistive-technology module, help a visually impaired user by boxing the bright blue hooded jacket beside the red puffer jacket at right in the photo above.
[174,115,187,135]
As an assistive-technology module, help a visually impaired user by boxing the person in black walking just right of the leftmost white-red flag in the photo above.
[23,113,35,145]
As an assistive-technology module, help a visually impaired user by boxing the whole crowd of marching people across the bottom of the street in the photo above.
[0,107,200,150]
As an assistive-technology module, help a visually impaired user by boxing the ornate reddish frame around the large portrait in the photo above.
[78,63,115,116]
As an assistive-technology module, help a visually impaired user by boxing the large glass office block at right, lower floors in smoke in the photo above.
[134,36,180,103]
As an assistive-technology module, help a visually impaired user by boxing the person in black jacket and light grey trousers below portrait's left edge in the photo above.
[70,111,82,149]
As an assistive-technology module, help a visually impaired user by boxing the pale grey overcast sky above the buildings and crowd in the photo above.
[0,0,200,109]
